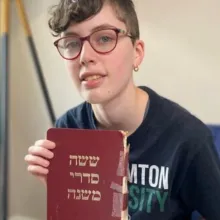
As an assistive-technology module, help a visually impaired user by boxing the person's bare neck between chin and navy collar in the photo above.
[92,84,148,135]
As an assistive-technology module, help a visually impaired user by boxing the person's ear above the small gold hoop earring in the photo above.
[134,40,145,67]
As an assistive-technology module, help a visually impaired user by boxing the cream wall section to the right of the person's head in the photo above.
[136,0,220,123]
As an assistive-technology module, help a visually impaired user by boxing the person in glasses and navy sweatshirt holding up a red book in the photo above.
[25,0,220,220]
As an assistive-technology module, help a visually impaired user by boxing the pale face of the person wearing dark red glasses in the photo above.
[60,5,143,104]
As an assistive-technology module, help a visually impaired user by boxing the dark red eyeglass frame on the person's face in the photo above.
[53,28,134,60]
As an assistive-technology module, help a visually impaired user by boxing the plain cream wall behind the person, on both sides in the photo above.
[1,0,220,220]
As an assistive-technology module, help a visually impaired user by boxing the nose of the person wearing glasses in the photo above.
[80,41,96,66]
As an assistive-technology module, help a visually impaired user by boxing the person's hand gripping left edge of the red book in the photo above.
[24,140,55,185]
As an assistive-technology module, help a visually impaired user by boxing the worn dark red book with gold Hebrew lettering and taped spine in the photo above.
[47,128,129,220]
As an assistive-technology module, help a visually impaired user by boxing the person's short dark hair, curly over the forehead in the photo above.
[48,0,140,39]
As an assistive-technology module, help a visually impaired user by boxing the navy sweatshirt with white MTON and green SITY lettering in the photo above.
[56,86,220,220]
